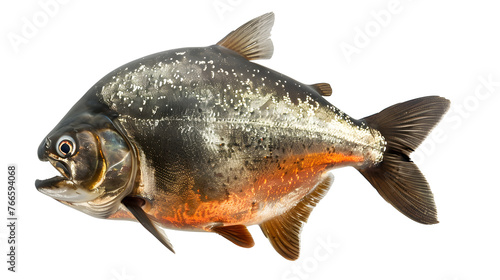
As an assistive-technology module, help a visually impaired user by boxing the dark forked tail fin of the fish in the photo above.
[359,96,450,224]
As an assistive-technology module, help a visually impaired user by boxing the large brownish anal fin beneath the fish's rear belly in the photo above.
[260,174,333,260]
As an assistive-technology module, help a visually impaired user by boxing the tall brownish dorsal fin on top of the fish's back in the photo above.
[217,13,274,60]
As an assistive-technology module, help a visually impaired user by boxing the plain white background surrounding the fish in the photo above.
[0,0,500,280]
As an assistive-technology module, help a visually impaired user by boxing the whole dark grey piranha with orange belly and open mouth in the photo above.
[35,13,449,260]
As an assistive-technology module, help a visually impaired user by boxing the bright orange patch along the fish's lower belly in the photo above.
[110,153,364,231]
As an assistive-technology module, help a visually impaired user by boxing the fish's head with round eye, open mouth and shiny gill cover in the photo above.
[35,114,136,218]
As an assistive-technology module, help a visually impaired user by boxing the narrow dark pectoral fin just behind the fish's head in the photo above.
[122,196,175,254]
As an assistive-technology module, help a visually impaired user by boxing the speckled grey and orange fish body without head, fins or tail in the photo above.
[98,45,384,230]
